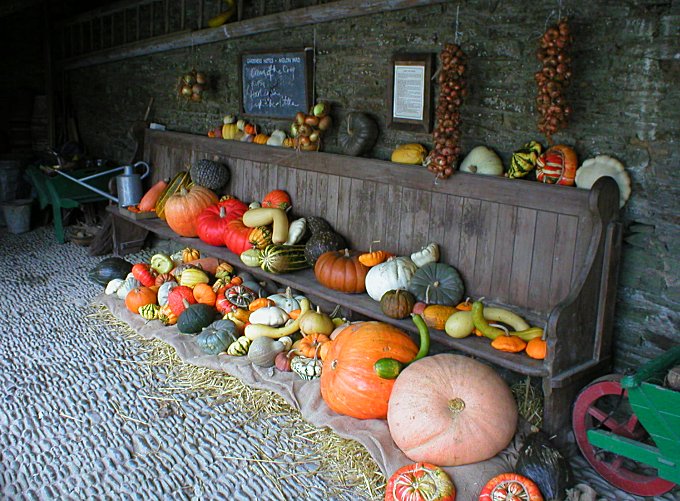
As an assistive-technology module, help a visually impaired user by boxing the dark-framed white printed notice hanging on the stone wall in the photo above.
[387,54,432,132]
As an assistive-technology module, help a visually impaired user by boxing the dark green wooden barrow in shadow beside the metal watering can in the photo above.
[26,166,114,244]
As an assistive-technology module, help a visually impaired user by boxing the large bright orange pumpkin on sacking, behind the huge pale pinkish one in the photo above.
[321,322,418,419]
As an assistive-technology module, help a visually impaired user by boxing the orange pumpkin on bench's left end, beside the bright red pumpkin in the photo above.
[165,184,218,237]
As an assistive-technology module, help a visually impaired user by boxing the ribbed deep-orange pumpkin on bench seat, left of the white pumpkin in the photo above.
[314,249,369,294]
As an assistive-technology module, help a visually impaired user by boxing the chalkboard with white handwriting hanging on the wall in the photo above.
[239,50,312,119]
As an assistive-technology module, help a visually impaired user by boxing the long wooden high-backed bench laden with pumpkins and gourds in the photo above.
[111,131,621,440]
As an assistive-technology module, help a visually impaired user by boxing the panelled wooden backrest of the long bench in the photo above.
[145,131,602,319]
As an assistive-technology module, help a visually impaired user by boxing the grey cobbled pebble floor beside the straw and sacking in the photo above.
[0,227,676,501]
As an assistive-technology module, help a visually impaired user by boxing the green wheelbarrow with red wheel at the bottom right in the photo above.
[572,346,680,496]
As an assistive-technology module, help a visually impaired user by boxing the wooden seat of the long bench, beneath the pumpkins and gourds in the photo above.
[108,206,548,377]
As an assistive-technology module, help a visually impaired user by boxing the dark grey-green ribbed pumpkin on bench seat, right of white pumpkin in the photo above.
[408,263,465,306]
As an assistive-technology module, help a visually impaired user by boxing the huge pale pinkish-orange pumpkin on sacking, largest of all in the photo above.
[387,353,517,466]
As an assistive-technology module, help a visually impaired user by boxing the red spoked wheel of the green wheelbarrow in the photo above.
[572,374,675,496]
